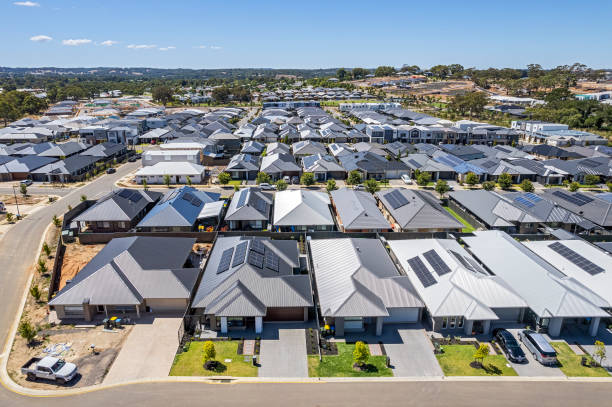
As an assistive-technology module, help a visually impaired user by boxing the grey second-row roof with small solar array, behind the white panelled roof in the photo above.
[376,188,463,229]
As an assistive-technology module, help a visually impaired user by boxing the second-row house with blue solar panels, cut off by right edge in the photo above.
[541,188,612,234]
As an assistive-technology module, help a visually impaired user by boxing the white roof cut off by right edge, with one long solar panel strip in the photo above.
[523,240,612,304]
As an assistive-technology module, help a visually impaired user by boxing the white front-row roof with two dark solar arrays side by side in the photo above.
[388,239,527,320]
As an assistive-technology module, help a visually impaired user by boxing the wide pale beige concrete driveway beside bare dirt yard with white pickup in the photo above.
[104,317,182,384]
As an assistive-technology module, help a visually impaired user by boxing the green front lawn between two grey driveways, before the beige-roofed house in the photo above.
[308,343,393,377]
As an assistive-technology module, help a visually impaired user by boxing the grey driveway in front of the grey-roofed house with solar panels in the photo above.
[259,323,308,377]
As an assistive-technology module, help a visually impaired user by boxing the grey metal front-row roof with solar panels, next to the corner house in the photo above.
[192,236,314,317]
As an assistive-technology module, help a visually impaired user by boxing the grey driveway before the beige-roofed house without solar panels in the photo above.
[346,324,443,377]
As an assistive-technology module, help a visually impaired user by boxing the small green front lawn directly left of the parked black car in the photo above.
[436,345,517,376]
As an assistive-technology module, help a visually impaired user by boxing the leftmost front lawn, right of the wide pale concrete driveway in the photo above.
[170,341,257,377]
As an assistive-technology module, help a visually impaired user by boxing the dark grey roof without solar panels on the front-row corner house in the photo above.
[49,236,199,305]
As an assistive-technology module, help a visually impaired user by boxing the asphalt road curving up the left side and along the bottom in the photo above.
[0,159,612,407]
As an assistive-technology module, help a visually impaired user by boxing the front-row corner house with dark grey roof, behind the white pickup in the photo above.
[49,236,200,322]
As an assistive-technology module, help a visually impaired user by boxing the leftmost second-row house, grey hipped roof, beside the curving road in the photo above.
[73,188,163,233]
